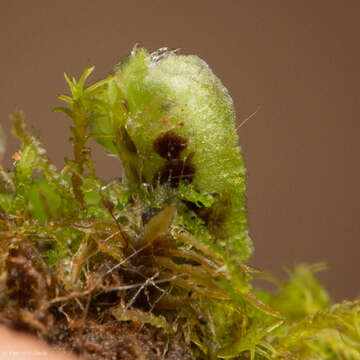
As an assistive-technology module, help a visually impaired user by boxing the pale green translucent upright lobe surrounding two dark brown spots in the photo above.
[92,48,253,272]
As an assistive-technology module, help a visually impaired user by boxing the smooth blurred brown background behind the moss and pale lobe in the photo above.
[0,0,360,300]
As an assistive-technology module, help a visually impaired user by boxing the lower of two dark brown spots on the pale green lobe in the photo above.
[154,153,195,188]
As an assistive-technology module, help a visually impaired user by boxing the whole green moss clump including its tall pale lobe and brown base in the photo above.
[0,48,360,360]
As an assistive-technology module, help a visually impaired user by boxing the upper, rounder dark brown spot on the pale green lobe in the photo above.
[154,131,187,160]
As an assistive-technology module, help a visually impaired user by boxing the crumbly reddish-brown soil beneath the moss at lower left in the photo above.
[0,239,194,360]
